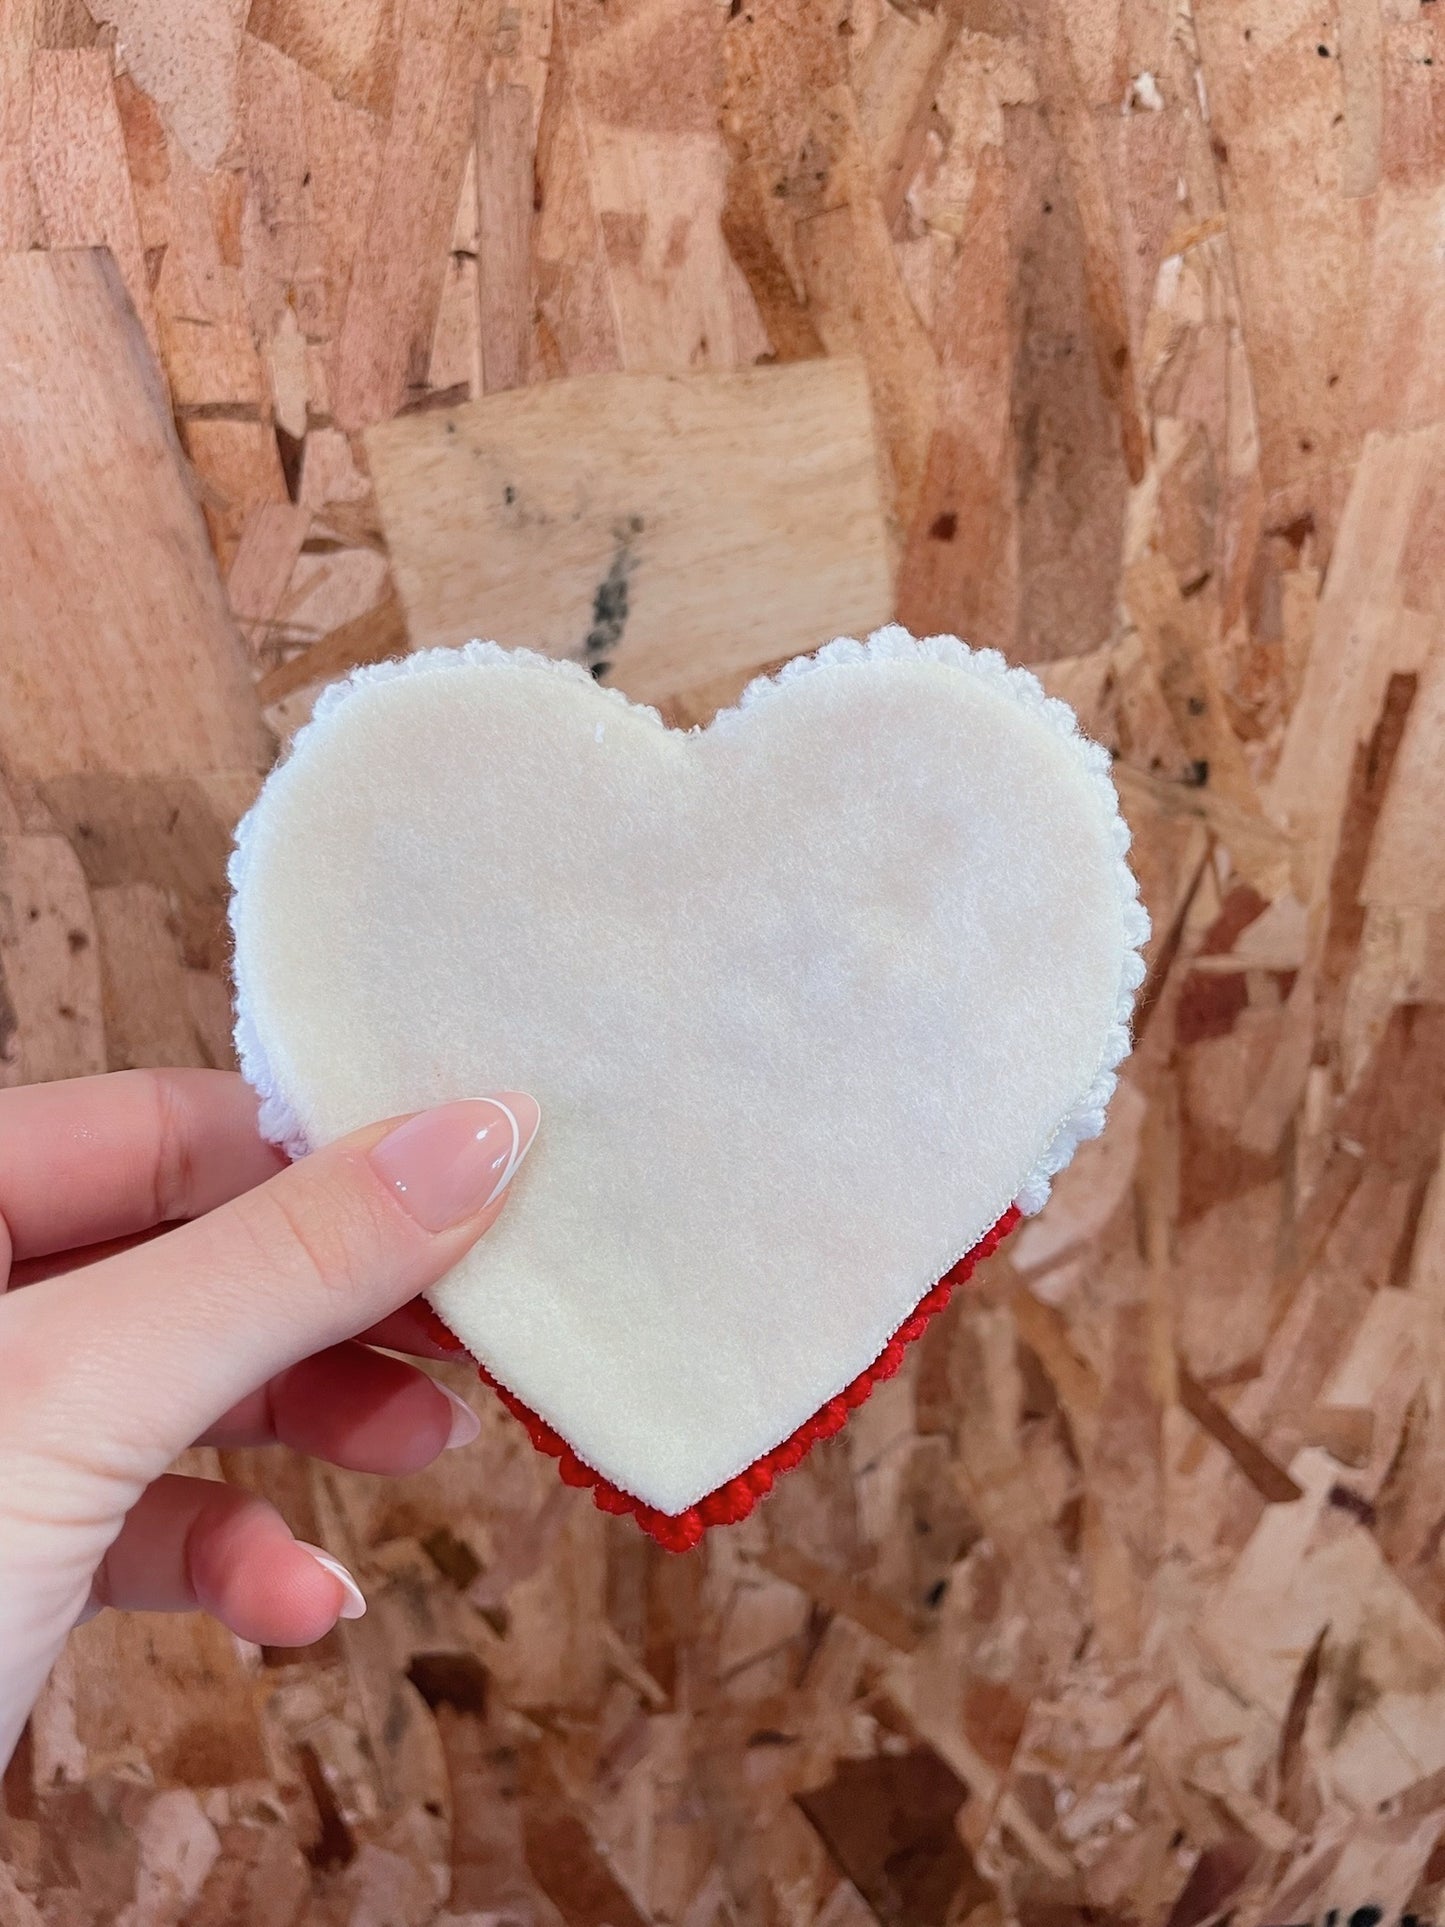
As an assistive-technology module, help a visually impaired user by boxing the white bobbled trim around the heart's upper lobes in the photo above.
[227,622,1150,1216]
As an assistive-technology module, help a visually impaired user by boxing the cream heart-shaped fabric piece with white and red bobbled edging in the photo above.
[231,628,1148,1545]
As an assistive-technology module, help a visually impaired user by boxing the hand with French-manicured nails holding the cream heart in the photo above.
[0,1071,538,1765]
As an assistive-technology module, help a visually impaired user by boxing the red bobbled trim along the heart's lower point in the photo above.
[437,1204,1021,1553]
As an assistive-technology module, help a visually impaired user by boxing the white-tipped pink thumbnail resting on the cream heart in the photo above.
[370,1091,541,1231]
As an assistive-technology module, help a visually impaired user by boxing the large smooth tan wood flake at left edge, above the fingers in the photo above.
[0,249,266,780]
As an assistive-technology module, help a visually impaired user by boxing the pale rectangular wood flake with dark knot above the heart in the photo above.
[366,360,892,701]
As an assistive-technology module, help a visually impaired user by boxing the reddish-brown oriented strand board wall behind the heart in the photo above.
[0,0,1445,1927]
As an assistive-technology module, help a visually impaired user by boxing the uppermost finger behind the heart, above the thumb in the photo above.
[0,1069,287,1264]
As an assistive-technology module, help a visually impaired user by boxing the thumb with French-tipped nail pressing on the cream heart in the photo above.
[6,1091,539,1480]
